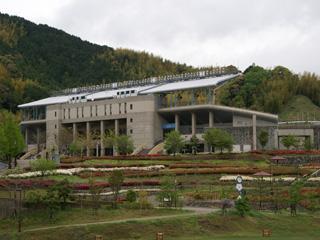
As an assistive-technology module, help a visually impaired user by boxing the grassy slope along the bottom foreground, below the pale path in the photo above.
[6,213,320,240]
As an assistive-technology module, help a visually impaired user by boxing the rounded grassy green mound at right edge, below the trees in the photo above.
[279,95,320,121]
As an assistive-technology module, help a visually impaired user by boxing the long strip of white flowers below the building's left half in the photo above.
[6,165,165,178]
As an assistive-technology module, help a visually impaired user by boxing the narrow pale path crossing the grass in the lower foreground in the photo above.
[23,207,219,232]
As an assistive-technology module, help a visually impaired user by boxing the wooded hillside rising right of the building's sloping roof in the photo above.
[218,66,320,117]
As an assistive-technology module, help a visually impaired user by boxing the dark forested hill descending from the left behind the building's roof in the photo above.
[0,14,193,110]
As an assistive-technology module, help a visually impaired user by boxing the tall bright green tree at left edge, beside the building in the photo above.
[0,111,25,168]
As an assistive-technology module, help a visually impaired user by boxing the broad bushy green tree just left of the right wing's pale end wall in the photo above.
[203,128,233,152]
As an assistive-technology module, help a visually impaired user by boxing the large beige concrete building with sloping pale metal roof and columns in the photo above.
[19,70,278,155]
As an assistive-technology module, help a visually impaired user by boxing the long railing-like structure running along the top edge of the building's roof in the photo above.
[53,67,239,95]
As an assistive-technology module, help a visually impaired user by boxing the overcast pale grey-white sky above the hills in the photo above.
[0,0,320,74]
